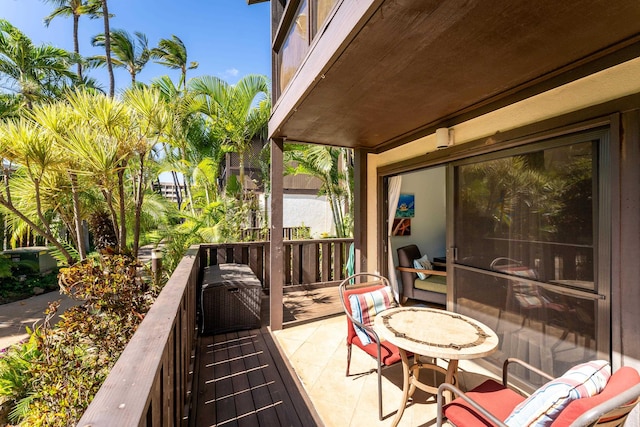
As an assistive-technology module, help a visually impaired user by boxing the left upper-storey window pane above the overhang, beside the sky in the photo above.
[279,0,309,91]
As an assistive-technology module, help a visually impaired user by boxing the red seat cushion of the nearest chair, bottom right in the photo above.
[443,380,525,427]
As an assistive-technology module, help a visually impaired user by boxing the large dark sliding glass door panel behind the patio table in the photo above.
[449,129,610,383]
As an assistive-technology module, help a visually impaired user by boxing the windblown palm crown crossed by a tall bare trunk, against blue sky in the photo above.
[90,30,150,86]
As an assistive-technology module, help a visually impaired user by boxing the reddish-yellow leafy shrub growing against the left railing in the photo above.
[0,255,159,426]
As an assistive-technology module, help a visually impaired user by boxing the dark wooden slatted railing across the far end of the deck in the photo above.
[200,239,353,289]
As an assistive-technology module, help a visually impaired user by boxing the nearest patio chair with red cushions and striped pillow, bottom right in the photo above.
[436,358,640,427]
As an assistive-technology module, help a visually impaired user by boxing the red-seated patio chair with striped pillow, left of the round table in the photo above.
[338,273,410,421]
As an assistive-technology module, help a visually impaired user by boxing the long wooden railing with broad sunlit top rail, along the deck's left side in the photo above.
[78,246,200,427]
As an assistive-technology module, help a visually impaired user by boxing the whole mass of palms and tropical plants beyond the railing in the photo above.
[0,8,352,425]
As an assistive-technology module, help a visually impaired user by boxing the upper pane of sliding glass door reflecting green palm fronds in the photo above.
[455,142,595,289]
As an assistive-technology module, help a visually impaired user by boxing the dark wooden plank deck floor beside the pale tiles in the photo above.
[189,286,342,427]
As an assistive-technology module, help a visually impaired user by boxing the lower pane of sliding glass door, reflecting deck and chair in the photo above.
[455,269,597,385]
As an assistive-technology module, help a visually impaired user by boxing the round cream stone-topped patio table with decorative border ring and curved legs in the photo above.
[374,307,498,426]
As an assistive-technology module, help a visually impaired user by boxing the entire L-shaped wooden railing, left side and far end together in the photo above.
[78,239,352,427]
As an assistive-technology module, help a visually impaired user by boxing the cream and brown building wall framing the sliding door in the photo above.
[367,59,640,426]
